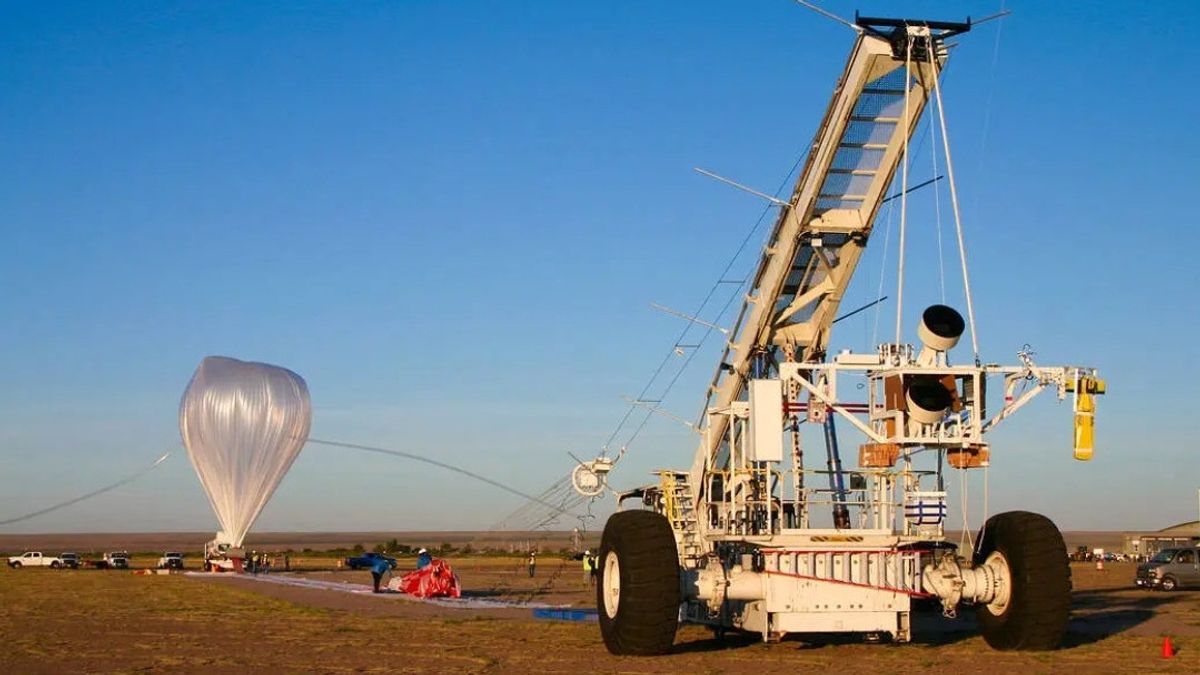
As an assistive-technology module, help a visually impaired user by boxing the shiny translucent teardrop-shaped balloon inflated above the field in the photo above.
[179,357,312,548]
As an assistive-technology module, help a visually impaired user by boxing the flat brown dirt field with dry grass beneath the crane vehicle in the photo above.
[0,558,1200,674]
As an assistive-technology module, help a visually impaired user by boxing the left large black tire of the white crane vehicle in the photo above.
[596,510,679,656]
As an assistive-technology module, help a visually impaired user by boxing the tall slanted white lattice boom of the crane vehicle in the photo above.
[691,24,950,494]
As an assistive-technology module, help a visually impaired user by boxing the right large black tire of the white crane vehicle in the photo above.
[974,510,1070,651]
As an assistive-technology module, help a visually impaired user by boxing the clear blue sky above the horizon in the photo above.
[0,0,1200,532]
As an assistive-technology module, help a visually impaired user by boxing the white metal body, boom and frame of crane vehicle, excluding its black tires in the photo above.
[614,22,1096,641]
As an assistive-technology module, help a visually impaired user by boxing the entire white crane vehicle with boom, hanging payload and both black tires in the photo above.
[590,11,1106,655]
